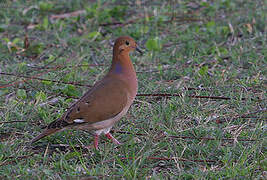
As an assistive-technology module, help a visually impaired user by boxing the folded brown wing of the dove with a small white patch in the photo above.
[48,79,131,129]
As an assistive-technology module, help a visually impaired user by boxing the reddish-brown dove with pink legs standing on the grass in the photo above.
[31,36,142,150]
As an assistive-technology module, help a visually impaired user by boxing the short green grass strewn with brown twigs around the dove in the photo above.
[0,0,267,179]
